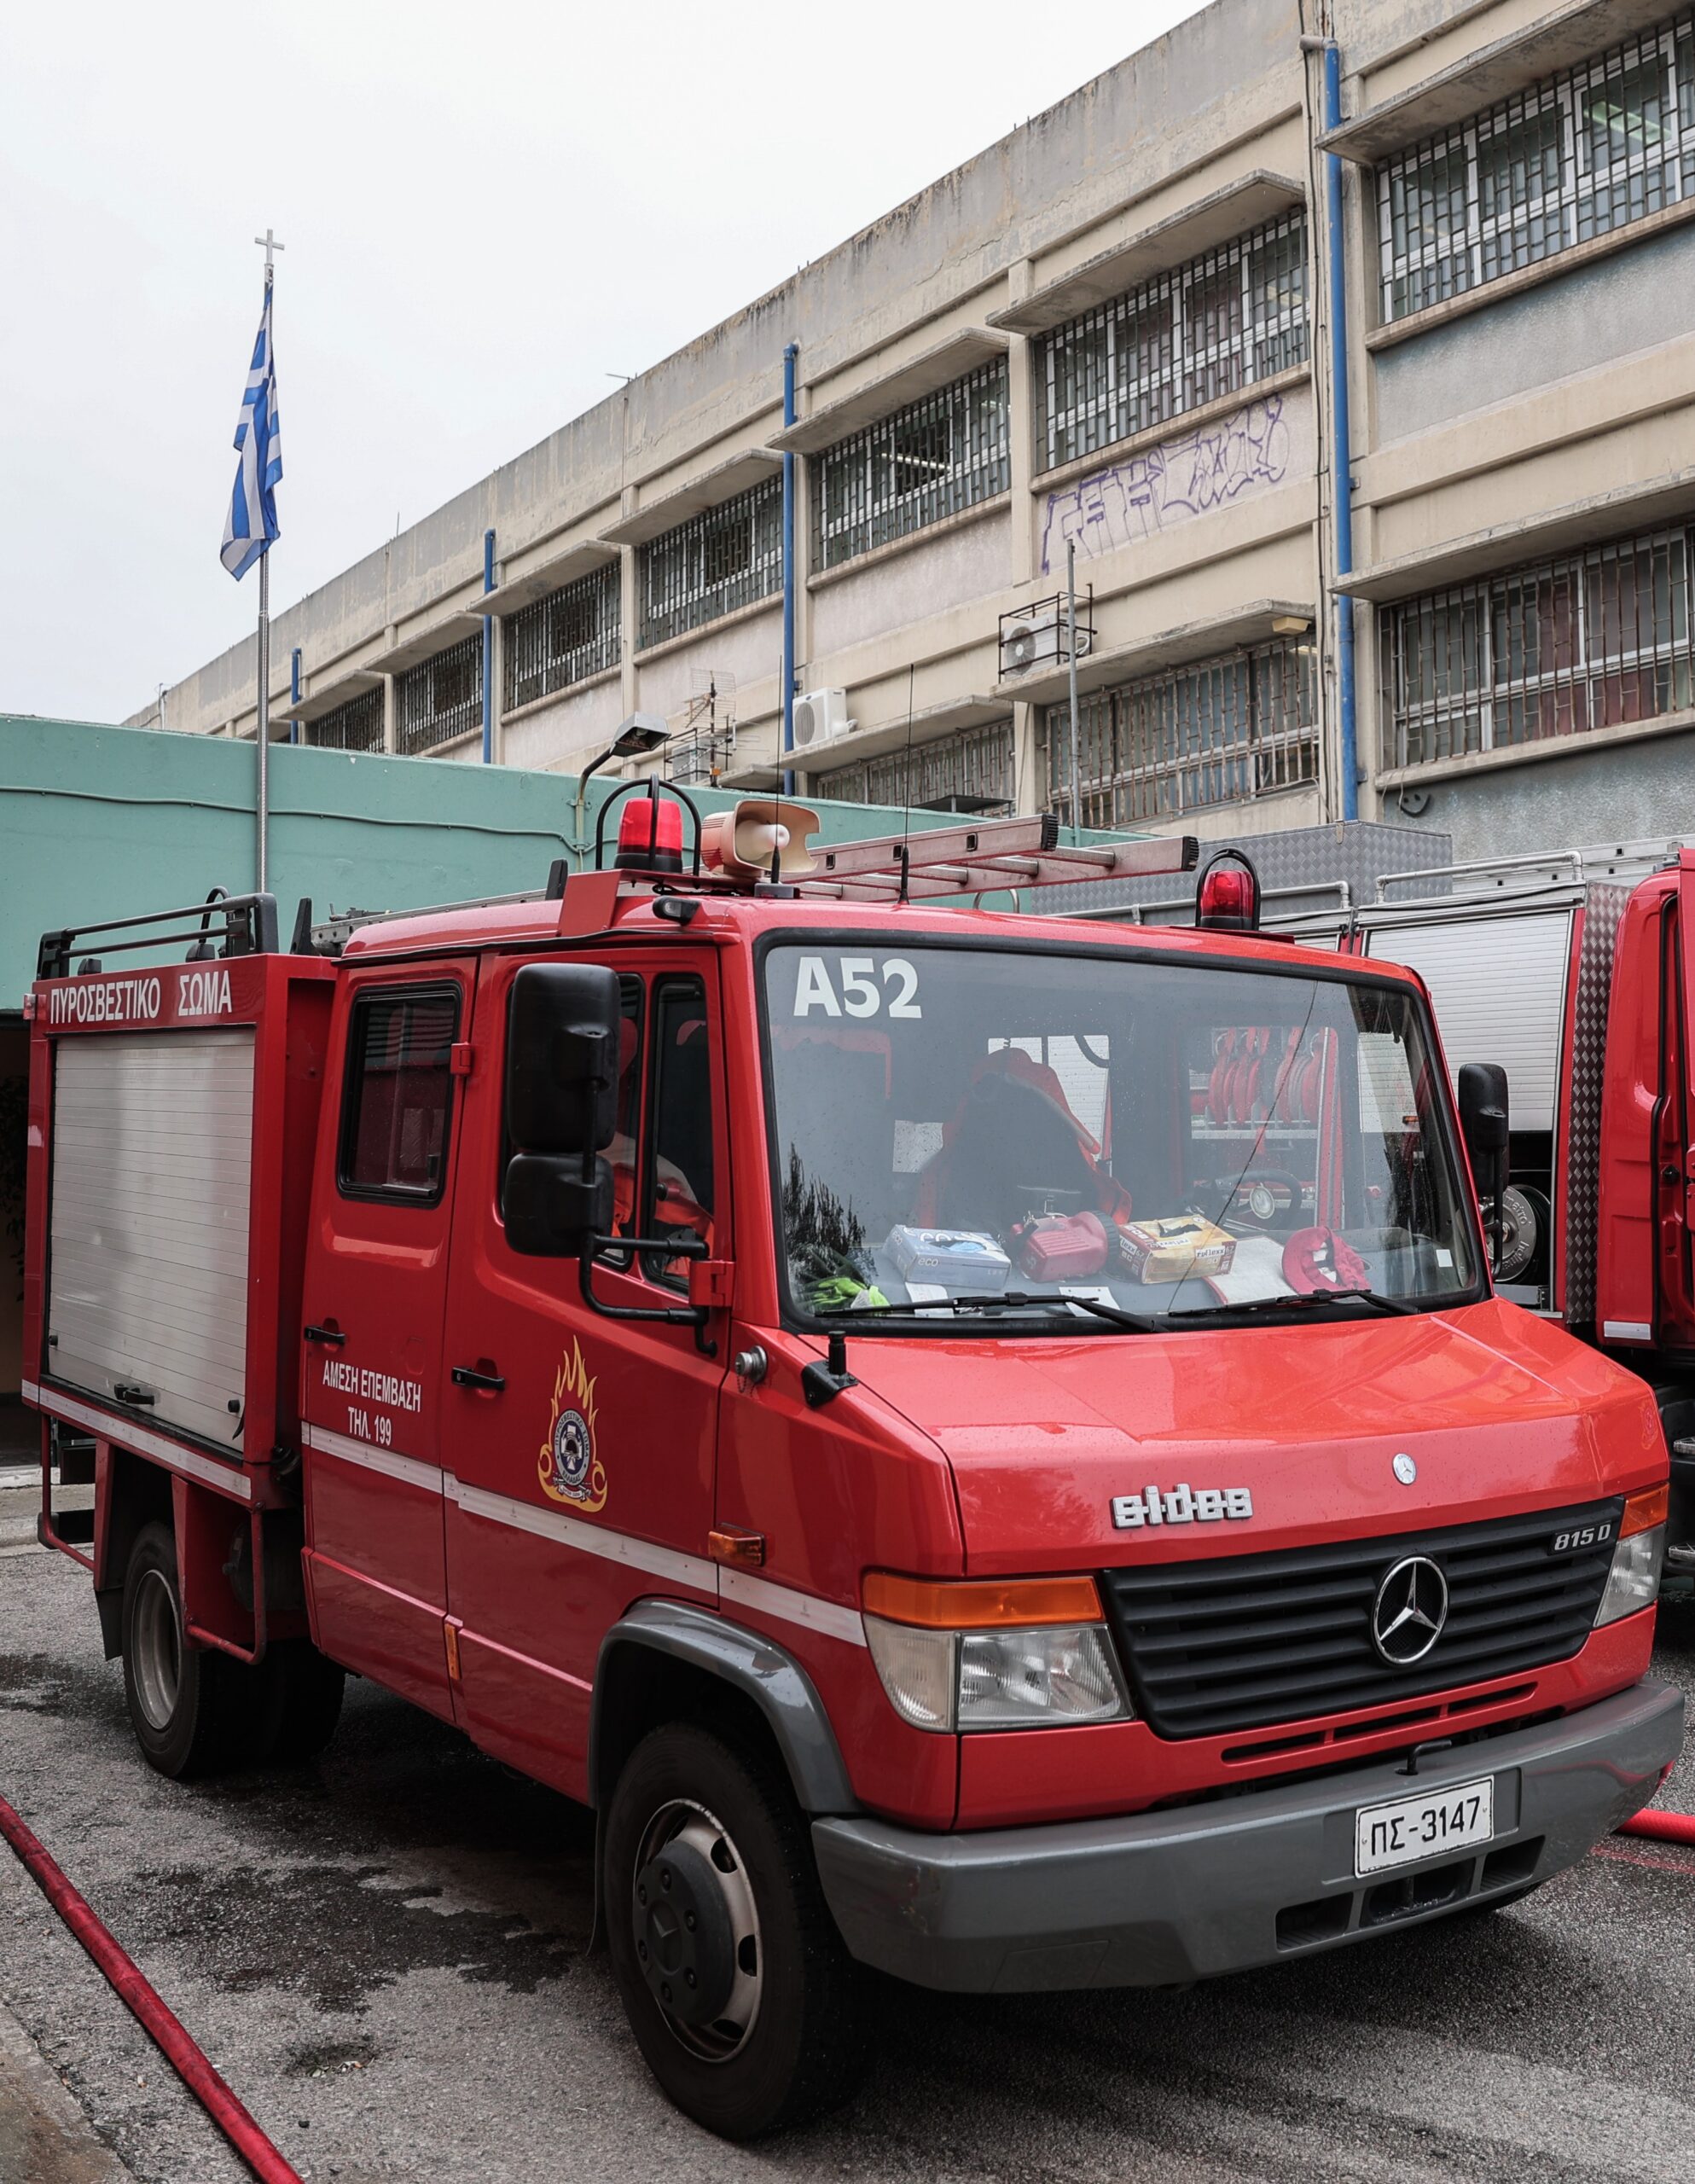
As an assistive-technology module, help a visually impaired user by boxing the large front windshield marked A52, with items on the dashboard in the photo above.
[764,939,1477,1327]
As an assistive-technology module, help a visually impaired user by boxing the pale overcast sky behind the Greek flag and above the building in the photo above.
[0,0,1199,721]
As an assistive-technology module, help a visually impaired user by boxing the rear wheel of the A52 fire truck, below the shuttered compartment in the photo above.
[122,1522,251,1782]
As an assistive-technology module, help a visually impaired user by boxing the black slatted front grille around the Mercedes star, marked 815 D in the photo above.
[1103,1501,1623,1736]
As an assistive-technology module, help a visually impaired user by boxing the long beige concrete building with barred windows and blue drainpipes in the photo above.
[133,0,1695,857]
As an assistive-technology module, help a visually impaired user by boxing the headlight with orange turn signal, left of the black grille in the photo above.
[865,1571,1131,1730]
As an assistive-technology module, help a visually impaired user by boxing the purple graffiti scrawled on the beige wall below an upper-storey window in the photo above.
[1042,395,1289,574]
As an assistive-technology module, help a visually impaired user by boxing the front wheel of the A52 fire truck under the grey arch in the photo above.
[603,1723,868,2140]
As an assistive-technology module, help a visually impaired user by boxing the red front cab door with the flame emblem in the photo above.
[441,950,729,1798]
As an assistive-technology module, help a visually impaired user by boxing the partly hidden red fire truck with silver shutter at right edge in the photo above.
[1257,841,1695,1586]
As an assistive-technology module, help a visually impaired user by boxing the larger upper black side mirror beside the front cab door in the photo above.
[507,963,620,1153]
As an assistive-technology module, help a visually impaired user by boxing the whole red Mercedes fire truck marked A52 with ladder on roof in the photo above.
[26,793,1682,2136]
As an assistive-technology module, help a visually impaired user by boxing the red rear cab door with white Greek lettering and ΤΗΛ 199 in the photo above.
[301,959,476,1716]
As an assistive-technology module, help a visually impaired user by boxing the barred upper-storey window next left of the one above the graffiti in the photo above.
[813,356,1012,568]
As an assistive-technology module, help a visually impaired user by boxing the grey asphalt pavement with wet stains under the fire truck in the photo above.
[0,1491,1695,2184]
